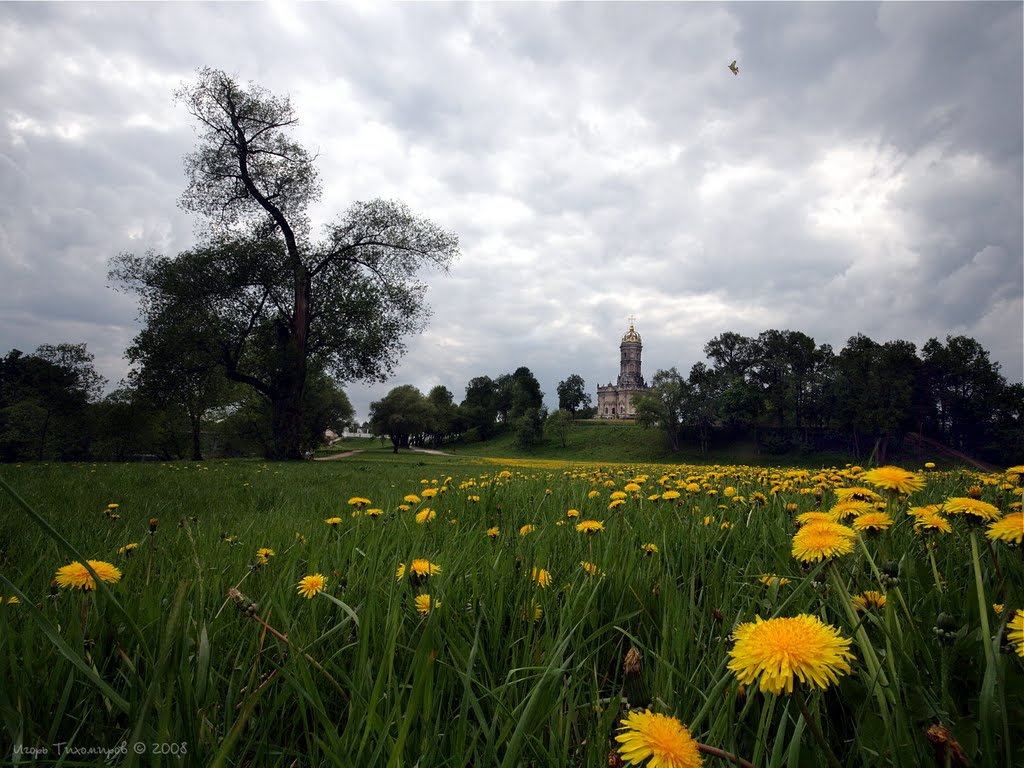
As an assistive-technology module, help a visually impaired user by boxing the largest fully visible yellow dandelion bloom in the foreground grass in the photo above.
[728,613,853,695]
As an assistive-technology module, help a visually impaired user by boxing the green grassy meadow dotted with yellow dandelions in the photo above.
[0,454,1024,768]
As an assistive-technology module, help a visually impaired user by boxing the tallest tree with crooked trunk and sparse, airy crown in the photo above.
[112,69,459,459]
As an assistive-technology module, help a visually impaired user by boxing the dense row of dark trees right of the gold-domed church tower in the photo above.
[634,330,1024,464]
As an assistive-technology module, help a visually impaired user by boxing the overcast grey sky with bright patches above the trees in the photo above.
[0,2,1024,419]
